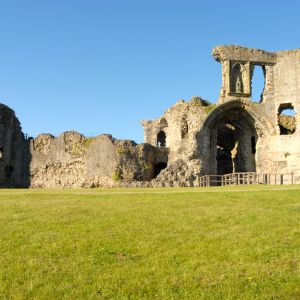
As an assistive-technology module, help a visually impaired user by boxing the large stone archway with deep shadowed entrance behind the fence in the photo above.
[197,100,276,174]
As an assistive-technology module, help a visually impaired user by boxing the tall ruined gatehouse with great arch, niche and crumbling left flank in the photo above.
[142,46,300,186]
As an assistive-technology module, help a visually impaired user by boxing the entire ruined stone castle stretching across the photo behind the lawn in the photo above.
[0,46,300,187]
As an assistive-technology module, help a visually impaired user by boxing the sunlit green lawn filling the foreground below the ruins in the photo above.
[0,186,300,299]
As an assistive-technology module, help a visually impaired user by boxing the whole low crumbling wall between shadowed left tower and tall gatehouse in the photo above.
[30,131,167,188]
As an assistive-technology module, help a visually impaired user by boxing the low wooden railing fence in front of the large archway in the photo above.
[199,172,295,187]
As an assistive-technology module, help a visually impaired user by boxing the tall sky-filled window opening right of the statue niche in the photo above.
[251,66,266,103]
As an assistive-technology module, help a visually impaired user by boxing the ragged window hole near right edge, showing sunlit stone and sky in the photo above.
[278,103,296,135]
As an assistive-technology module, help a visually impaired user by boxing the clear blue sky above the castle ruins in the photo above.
[0,0,300,142]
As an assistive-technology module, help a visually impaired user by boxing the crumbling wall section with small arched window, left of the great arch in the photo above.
[142,97,215,186]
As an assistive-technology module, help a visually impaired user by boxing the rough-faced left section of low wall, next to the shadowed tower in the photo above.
[30,132,86,188]
